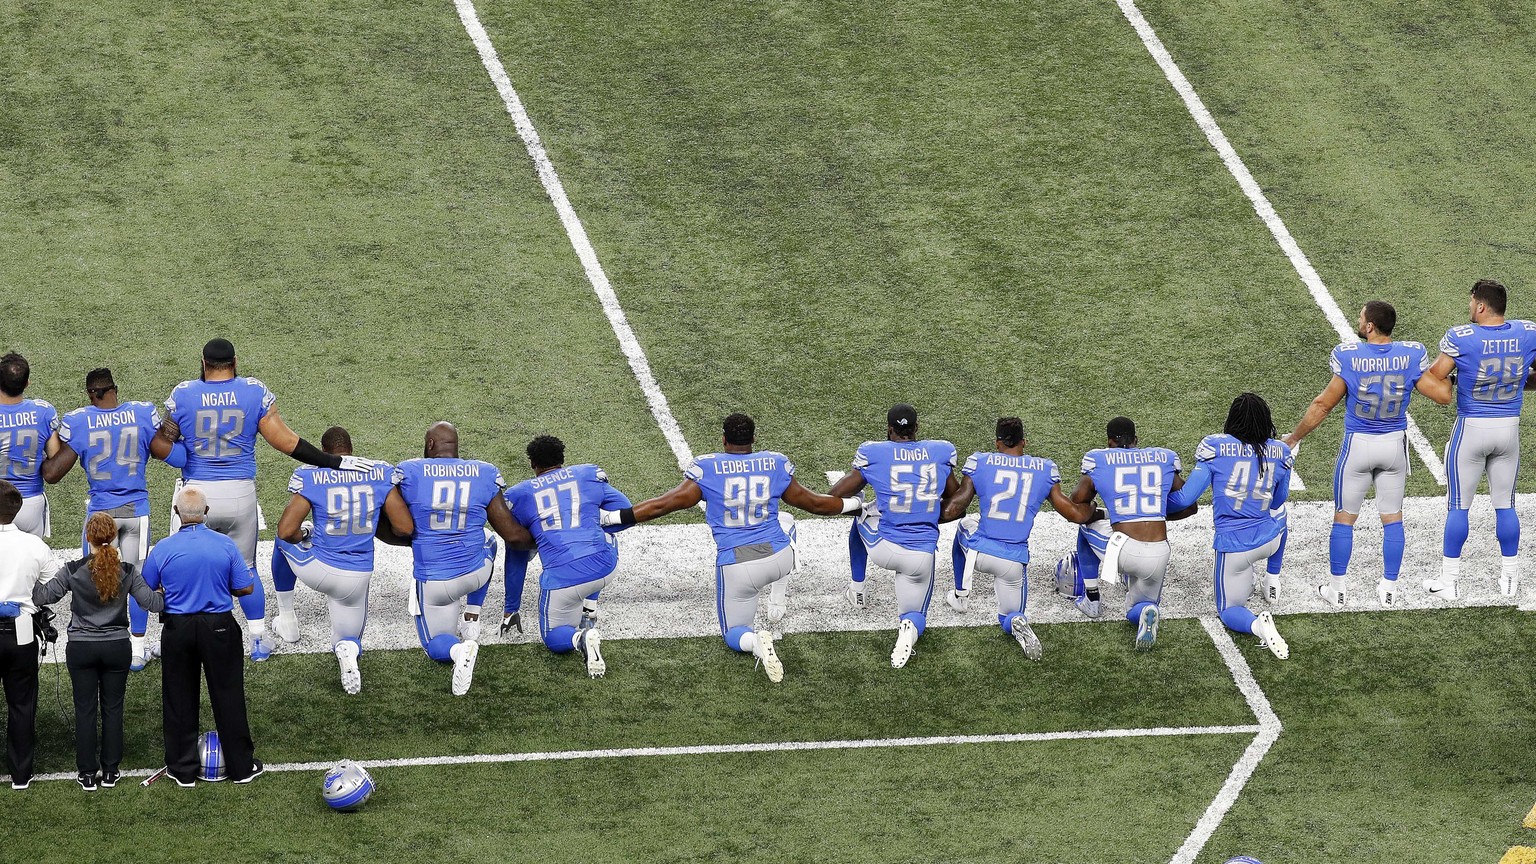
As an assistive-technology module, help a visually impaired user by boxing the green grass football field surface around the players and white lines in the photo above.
[0,0,1536,864]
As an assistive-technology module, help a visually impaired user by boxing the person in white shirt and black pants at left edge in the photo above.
[0,480,54,789]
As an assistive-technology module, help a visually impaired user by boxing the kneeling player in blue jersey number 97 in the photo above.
[507,435,630,678]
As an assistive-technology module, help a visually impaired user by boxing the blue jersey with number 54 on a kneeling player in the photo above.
[854,441,955,552]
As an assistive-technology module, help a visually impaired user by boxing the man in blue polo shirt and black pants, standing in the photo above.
[144,487,263,786]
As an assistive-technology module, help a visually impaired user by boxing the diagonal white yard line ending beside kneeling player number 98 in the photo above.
[453,0,693,467]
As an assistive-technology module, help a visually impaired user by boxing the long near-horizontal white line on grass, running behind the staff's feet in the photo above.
[32,726,1260,781]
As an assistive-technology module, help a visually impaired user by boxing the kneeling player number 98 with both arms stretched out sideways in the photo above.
[602,414,863,683]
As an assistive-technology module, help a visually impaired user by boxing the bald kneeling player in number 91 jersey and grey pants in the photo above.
[384,421,531,696]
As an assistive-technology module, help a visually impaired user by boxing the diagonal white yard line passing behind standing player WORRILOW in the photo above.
[1115,0,1445,486]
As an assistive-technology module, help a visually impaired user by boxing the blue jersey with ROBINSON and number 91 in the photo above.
[393,458,507,581]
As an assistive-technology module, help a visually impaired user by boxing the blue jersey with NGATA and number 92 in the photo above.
[166,378,276,480]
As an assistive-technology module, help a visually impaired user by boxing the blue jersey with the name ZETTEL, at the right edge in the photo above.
[1441,318,1536,417]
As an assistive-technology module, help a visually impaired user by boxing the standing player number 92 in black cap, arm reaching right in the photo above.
[151,338,373,661]
